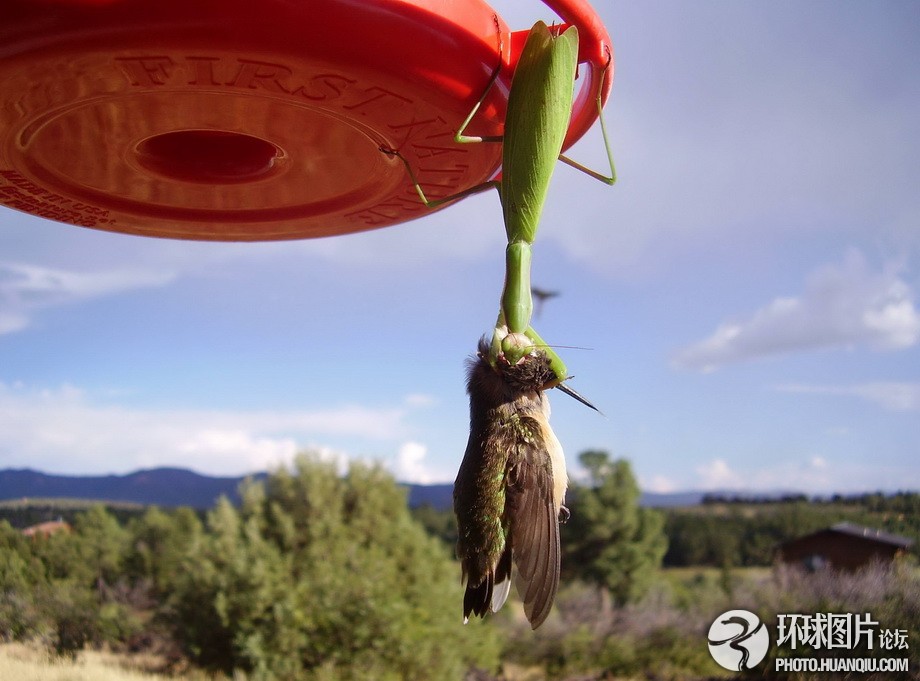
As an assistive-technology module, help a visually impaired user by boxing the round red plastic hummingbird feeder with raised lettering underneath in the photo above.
[0,0,612,241]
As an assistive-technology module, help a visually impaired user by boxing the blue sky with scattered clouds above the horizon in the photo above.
[0,0,920,493]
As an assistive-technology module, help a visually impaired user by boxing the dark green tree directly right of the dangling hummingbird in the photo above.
[563,450,667,604]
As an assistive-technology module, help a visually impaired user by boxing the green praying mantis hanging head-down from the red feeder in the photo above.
[382,21,616,394]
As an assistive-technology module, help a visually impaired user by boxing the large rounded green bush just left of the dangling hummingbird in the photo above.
[172,457,497,680]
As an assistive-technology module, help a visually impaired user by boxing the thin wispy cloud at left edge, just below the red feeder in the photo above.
[0,263,175,335]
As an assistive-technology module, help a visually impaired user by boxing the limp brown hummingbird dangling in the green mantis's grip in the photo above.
[454,338,594,629]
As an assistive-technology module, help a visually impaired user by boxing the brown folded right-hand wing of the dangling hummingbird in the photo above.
[507,417,560,629]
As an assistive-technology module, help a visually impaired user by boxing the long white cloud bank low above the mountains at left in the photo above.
[0,384,414,475]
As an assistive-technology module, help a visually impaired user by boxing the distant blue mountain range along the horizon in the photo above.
[0,468,703,509]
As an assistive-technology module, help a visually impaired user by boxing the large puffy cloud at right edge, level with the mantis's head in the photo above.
[674,250,920,371]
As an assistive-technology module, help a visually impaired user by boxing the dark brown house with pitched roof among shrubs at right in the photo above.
[776,523,913,570]
